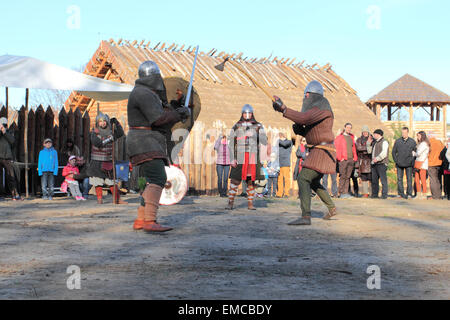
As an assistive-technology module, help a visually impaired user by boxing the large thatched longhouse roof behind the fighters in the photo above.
[66,40,390,136]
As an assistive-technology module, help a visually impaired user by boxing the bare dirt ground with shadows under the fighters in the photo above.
[0,192,450,299]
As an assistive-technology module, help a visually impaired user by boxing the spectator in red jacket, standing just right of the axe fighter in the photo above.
[334,123,358,199]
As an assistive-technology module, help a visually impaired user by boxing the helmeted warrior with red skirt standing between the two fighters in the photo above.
[226,104,267,210]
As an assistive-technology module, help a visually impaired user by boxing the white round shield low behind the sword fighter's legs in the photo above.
[159,166,188,206]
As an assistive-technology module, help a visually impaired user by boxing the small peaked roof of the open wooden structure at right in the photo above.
[367,74,450,104]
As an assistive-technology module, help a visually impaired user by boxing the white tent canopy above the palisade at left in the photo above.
[0,55,133,101]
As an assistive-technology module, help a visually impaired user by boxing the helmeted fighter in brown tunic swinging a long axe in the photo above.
[273,80,336,225]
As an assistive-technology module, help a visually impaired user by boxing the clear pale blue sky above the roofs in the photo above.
[0,0,450,122]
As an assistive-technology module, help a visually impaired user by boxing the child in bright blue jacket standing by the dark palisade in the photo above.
[38,139,58,200]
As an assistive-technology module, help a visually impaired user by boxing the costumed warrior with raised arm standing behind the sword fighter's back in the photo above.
[86,112,127,204]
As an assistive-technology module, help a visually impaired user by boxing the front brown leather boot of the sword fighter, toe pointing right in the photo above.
[142,184,172,232]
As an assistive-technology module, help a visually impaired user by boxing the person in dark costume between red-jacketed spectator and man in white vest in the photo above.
[356,126,372,198]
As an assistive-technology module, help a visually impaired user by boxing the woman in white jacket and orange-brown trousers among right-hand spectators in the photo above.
[413,131,430,200]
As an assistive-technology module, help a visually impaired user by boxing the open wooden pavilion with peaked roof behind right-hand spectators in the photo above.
[367,74,450,140]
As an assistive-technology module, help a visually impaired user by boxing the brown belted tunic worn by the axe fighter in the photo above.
[284,107,336,174]
